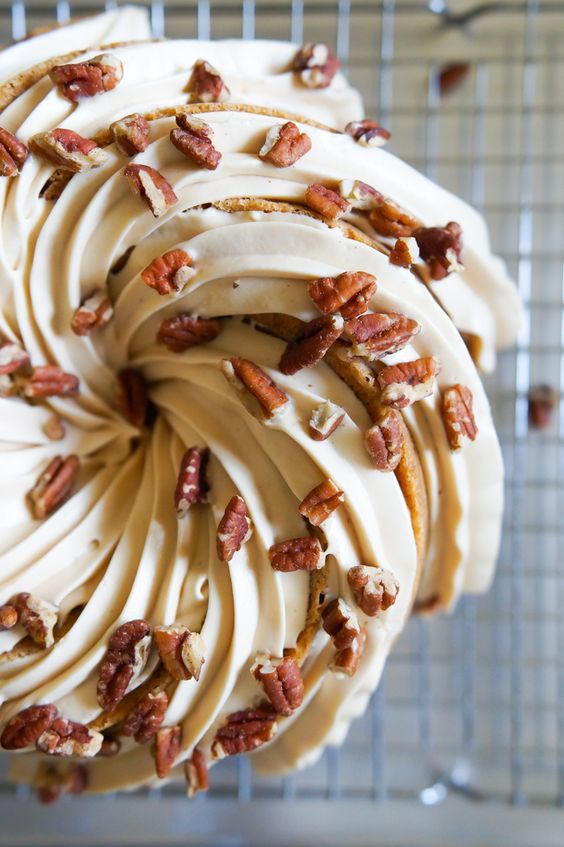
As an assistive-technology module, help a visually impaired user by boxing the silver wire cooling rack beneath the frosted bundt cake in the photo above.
[0,0,564,847]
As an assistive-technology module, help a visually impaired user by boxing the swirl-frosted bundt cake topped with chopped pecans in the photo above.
[0,7,519,801]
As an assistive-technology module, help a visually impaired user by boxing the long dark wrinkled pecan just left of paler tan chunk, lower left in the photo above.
[97,620,151,713]
